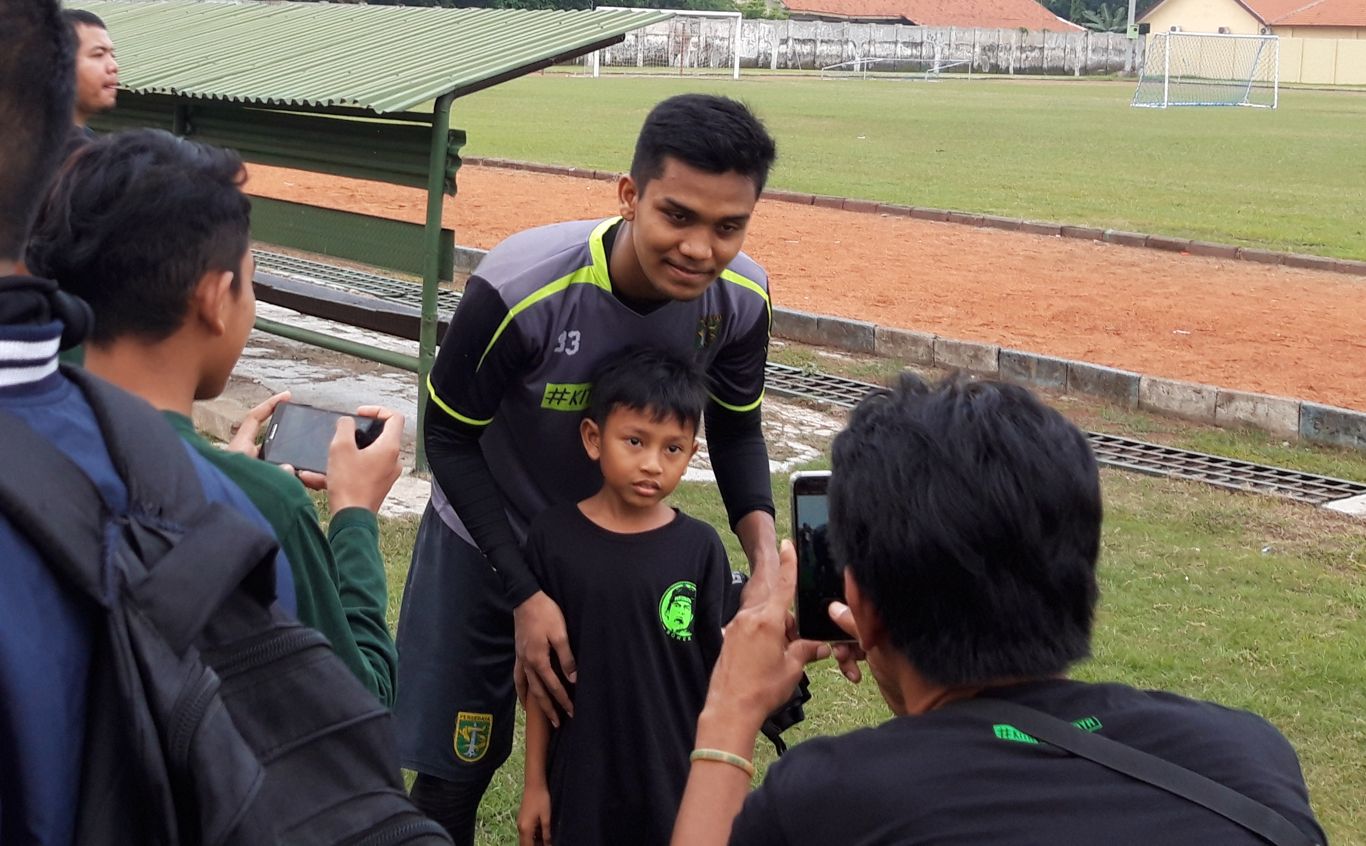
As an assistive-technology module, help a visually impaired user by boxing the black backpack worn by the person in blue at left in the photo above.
[0,368,449,846]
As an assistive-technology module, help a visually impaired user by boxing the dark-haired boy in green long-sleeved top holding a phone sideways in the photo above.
[27,130,403,705]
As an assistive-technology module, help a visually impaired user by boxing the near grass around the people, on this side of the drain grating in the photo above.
[366,399,1366,846]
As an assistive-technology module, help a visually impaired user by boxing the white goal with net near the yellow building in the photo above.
[1131,31,1280,109]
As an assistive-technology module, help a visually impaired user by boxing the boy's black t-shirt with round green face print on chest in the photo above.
[526,503,731,846]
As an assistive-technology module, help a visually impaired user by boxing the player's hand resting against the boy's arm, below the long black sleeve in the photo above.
[512,590,578,727]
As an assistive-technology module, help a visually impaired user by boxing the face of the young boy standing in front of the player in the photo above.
[581,407,697,508]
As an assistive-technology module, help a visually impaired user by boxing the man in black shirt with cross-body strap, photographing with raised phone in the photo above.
[673,377,1324,846]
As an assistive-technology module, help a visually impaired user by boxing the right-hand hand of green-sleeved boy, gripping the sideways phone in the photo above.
[326,406,403,514]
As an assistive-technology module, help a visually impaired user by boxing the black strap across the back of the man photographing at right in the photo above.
[949,697,1317,846]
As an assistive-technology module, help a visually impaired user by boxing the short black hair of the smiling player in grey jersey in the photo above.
[631,94,777,195]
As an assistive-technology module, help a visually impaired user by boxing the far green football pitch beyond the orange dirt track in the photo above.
[452,75,1366,258]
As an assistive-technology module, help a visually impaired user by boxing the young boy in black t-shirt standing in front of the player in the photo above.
[518,349,731,846]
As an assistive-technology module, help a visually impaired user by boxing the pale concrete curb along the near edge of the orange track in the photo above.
[445,232,1366,450]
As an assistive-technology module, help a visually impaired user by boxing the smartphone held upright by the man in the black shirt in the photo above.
[792,470,851,641]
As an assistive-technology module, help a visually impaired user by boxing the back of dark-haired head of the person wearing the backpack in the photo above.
[0,0,75,261]
